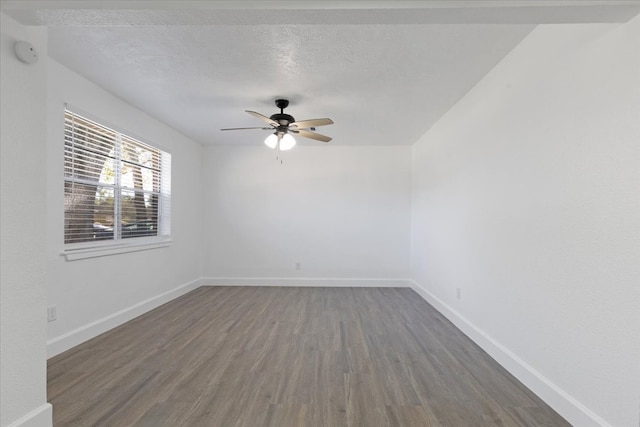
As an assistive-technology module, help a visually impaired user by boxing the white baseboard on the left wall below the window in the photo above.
[47,279,202,357]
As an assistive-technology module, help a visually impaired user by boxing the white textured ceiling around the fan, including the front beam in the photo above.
[3,0,638,145]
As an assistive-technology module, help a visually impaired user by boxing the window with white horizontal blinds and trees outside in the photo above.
[64,110,171,246]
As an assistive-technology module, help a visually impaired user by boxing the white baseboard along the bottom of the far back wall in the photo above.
[202,277,411,288]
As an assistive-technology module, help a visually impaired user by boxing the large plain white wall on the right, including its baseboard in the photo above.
[411,18,640,426]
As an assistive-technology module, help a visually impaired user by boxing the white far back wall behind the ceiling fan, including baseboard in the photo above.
[203,145,411,286]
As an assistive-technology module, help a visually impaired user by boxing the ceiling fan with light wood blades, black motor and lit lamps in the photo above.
[220,99,333,151]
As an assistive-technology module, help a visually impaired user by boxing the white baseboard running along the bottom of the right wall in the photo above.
[409,280,611,427]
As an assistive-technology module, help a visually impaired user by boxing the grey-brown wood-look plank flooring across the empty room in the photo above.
[48,287,569,427]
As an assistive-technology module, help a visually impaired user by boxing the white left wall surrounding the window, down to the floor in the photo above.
[46,60,202,356]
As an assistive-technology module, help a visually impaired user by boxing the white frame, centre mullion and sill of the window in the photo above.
[61,104,172,261]
